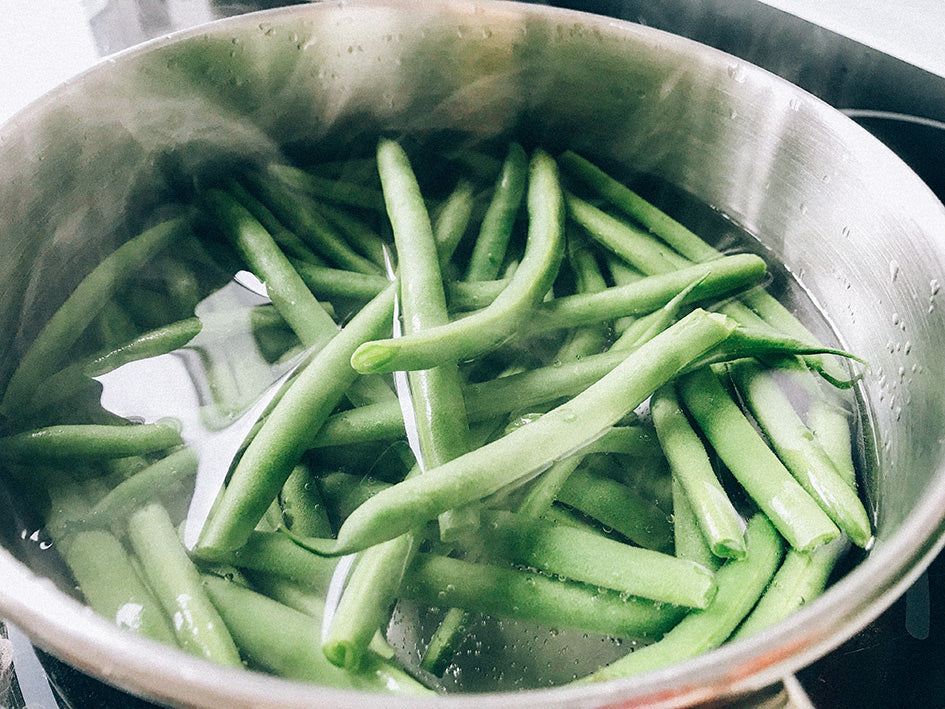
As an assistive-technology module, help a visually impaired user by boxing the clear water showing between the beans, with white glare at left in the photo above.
[4,147,868,692]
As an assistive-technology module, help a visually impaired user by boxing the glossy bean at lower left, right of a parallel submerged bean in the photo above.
[128,503,242,667]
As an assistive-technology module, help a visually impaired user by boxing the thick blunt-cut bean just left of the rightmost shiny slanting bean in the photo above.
[679,368,840,551]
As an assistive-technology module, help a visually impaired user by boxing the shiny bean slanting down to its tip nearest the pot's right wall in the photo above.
[729,360,873,547]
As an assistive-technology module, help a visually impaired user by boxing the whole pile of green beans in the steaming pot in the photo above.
[0,137,872,695]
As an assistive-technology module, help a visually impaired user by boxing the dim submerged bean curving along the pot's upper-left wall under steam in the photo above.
[0,217,188,417]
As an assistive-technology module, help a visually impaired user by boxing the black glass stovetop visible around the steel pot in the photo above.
[0,0,945,709]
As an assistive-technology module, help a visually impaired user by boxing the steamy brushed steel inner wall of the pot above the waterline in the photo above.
[0,3,945,704]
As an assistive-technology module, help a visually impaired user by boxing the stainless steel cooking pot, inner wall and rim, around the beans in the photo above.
[0,0,945,709]
